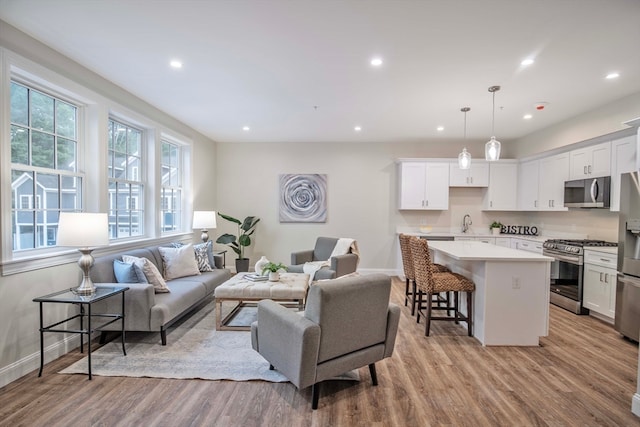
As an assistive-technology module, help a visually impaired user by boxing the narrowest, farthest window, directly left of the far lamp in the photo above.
[160,141,182,232]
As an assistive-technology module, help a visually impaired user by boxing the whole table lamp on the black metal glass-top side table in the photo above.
[57,212,109,295]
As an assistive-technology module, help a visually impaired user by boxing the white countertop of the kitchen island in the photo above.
[429,240,554,262]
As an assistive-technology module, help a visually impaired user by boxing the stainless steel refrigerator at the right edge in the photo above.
[615,171,640,341]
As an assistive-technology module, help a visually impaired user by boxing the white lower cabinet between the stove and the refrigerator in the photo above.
[582,249,617,319]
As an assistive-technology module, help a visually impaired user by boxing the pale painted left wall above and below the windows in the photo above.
[0,21,216,387]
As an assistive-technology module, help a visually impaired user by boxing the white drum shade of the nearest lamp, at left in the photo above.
[57,212,109,248]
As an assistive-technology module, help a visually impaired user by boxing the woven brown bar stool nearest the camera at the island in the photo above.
[410,238,476,337]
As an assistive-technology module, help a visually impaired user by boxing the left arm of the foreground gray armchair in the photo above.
[251,300,320,389]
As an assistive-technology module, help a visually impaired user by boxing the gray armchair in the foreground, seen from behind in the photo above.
[251,274,400,409]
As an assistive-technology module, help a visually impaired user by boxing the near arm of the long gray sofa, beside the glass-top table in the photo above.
[92,283,155,331]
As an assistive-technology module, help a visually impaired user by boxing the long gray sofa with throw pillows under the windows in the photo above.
[91,246,231,345]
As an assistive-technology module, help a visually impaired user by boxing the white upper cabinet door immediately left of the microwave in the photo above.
[538,153,569,211]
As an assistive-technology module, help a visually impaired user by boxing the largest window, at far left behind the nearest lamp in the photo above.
[10,81,82,251]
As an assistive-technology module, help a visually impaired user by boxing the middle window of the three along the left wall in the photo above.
[107,119,145,239]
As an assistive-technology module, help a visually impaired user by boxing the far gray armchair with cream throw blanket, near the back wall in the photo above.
[288,237,359,280]
